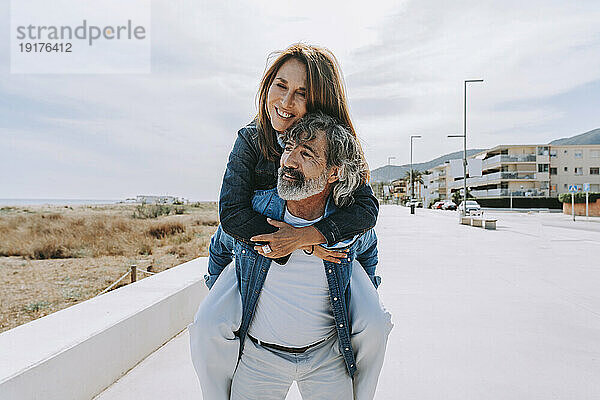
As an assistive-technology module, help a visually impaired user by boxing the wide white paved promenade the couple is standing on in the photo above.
[97,206,600,400]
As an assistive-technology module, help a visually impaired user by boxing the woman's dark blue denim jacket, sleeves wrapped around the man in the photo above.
[219,121,379,245]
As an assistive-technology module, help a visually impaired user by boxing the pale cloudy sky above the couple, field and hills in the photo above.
[0,0,600,200]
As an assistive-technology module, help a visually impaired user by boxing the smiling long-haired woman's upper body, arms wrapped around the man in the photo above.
[207,44,379,287]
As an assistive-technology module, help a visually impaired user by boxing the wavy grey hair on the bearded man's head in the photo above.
[283,112,368,207]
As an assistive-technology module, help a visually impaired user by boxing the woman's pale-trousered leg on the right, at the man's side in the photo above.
[350,262,394,400]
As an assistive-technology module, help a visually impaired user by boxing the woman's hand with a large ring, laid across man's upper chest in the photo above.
[250,218,325,258]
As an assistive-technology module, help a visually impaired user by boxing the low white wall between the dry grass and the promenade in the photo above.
[0,257,208,400]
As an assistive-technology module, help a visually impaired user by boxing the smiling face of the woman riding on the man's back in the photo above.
[267,58,306,132]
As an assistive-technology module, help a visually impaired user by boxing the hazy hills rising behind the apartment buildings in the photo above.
[371,128,600,182]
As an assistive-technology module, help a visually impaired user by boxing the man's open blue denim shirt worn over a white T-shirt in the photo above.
[205,188,381,376]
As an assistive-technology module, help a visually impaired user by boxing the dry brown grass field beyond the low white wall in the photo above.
[0,203,218,332]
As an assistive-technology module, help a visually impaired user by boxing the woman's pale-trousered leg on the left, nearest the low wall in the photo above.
[188,263,242,400]
